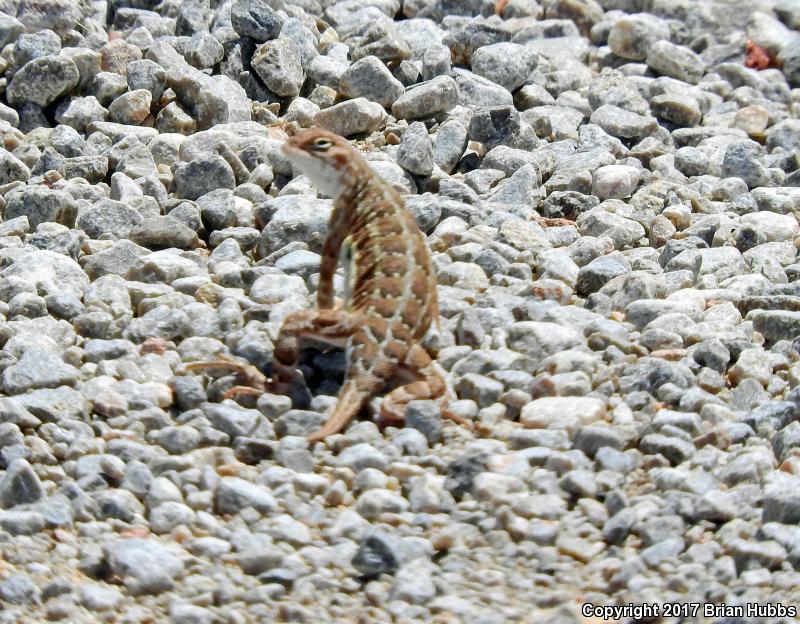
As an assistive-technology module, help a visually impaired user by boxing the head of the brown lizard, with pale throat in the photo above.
[282,128,361,199]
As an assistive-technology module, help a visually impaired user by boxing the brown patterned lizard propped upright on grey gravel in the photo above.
[187,128,470,443]
